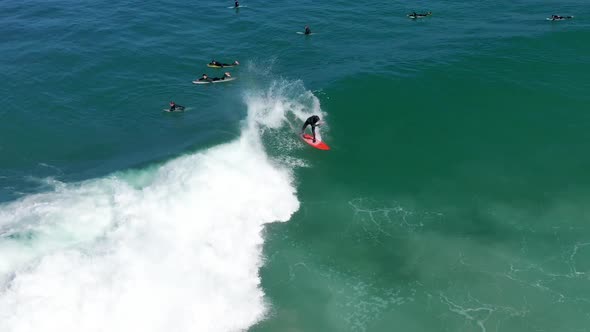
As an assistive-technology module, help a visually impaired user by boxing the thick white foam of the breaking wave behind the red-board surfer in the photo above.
[0,80,319,332]
